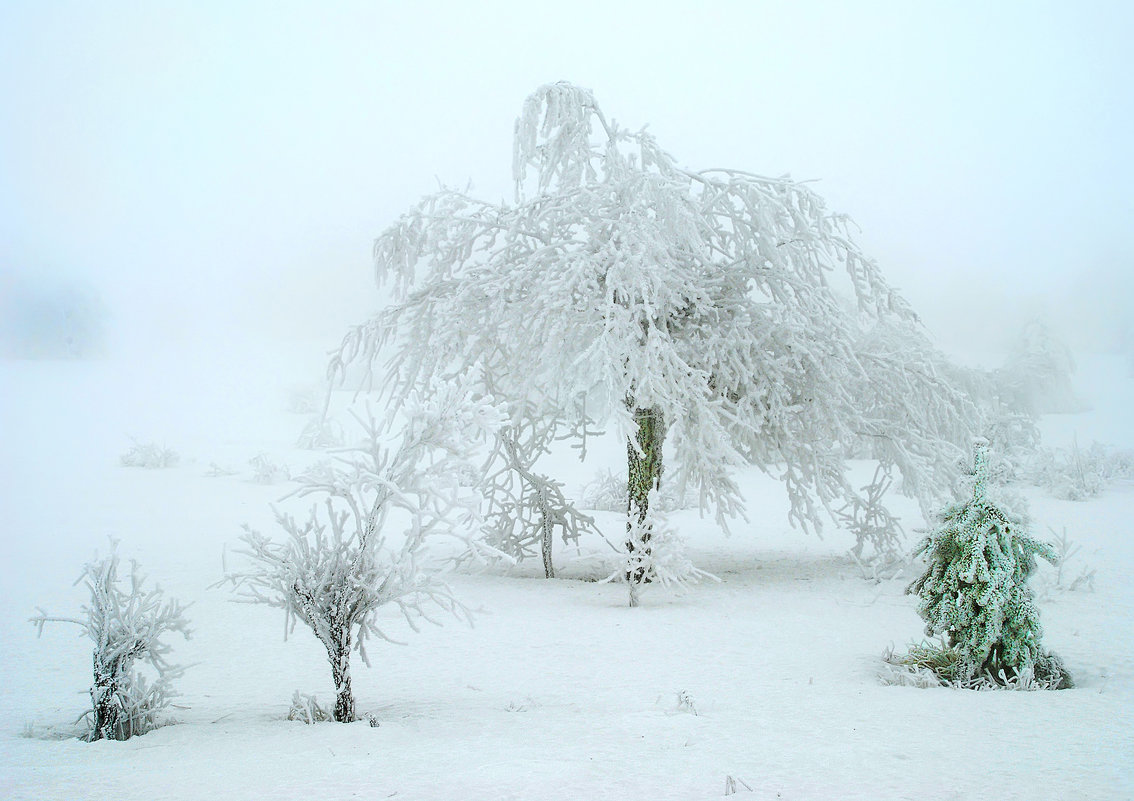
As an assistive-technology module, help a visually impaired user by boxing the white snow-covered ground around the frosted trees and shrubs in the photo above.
[0,349,1134,801]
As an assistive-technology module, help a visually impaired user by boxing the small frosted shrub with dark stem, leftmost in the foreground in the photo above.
[32,543,189,740]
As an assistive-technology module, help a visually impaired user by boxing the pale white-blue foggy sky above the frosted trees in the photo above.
[0,0,1134,358]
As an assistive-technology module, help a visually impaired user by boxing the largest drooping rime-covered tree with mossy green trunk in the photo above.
[332,83,967,585]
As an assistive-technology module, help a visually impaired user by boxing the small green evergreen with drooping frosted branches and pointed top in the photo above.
[906,439,1070,689]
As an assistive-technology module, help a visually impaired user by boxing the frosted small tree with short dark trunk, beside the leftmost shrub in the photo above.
[225,372,500,723]
